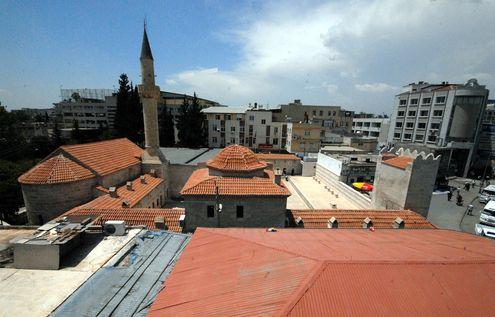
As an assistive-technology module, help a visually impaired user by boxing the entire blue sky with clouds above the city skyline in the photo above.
[0,0,495,114]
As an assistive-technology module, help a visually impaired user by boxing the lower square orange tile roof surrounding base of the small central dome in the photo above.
[181,168,290,196]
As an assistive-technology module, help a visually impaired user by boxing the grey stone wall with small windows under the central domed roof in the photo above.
[184,196,287,232]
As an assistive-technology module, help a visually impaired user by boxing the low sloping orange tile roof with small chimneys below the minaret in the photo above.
[72,175,163,210]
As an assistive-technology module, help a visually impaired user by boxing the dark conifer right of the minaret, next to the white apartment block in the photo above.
[177,93,208,148]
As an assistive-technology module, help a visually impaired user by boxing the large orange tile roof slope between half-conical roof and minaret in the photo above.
[60,139,143,175]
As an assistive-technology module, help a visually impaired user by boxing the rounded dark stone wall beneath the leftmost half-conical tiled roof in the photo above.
[21,178,96,225]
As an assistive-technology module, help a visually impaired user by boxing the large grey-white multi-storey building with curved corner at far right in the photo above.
[387,79,488,177]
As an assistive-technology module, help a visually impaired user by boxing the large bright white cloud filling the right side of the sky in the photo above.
[167,0,495,112]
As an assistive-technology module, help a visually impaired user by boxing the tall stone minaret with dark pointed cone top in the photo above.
[138,23,167,177]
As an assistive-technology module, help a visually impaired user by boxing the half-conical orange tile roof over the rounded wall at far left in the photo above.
[18,154,95,184]
